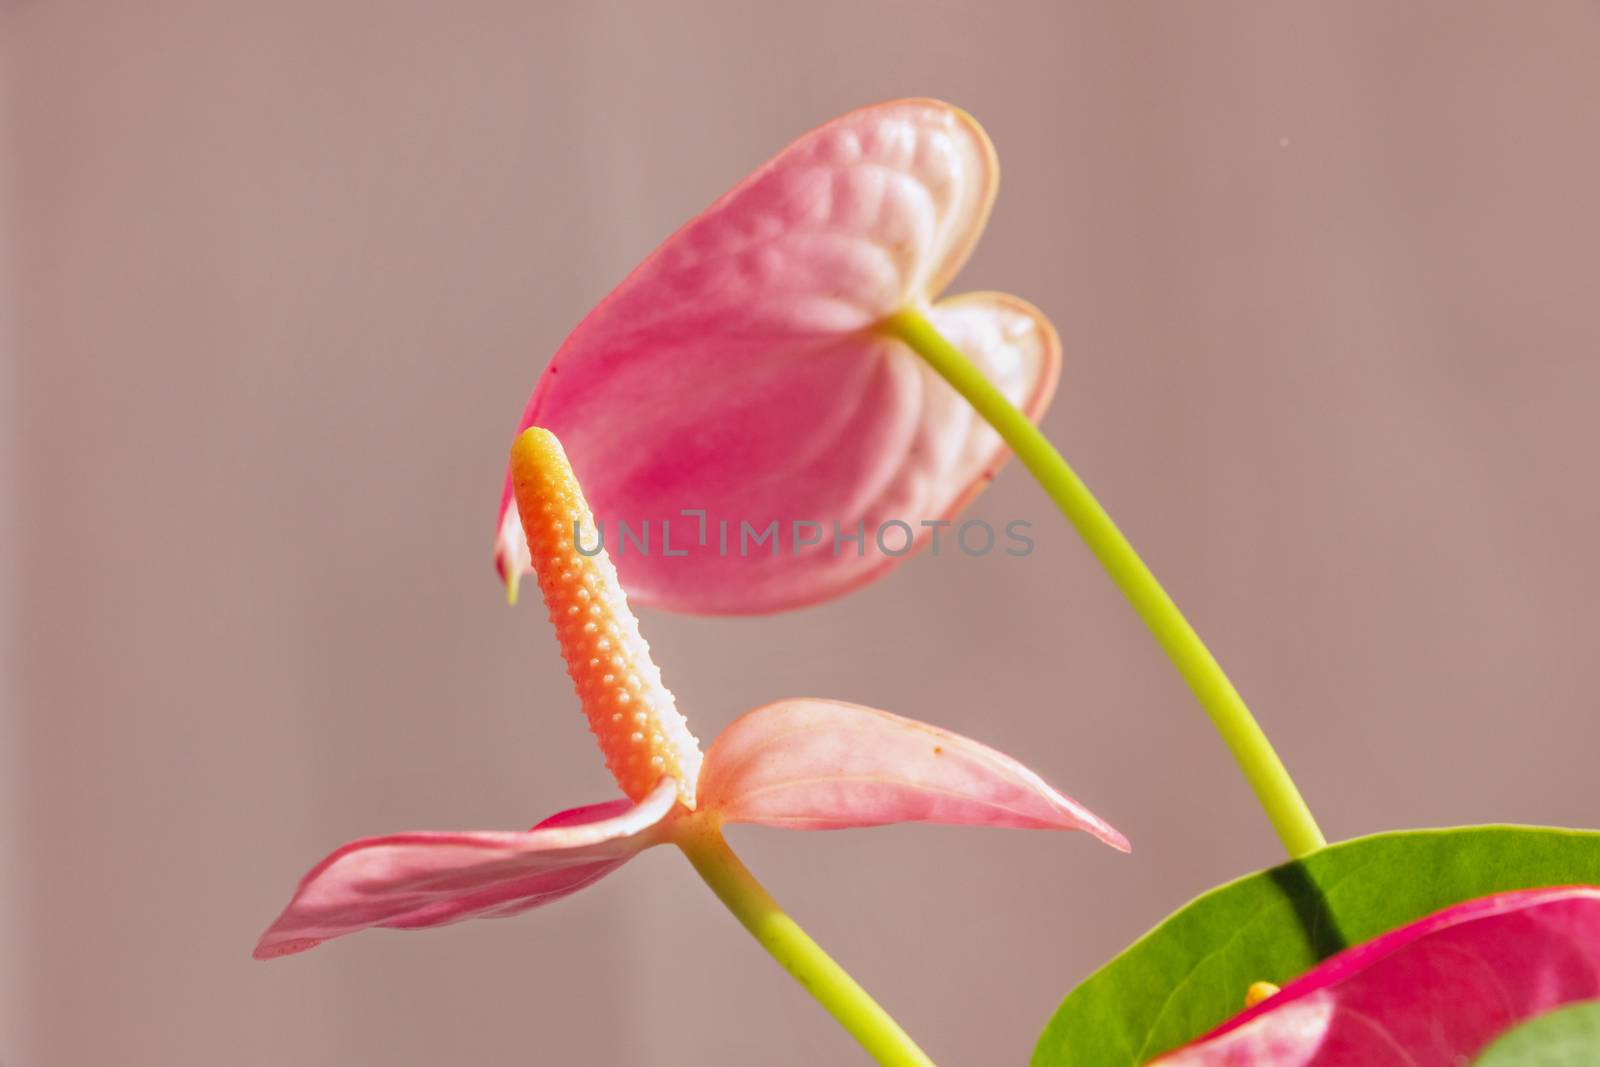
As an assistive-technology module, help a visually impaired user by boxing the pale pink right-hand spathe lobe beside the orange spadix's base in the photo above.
[701,701,1128,851]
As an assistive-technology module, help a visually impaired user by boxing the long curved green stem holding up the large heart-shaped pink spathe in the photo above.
[883,309,1326,859]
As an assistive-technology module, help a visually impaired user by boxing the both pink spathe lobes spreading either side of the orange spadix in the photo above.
[254,701,1128,960]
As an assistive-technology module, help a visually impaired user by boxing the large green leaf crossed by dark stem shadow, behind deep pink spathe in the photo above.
[1032,825,1600,1067]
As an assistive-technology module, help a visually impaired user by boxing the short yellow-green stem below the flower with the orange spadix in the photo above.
[677,819,933,1067]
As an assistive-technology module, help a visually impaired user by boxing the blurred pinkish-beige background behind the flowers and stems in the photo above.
[0,0,1600,1067]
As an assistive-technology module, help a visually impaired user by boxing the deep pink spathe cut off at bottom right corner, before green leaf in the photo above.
[1155,886,1600,1067]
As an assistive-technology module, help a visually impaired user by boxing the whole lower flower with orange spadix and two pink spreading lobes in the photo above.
[256,429,1128,958]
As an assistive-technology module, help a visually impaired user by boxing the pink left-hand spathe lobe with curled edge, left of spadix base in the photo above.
[254,779,678,960]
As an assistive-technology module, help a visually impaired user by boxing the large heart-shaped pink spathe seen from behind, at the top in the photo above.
[496,99,1061,614]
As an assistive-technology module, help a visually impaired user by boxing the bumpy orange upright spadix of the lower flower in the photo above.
[510,427,701,808]
